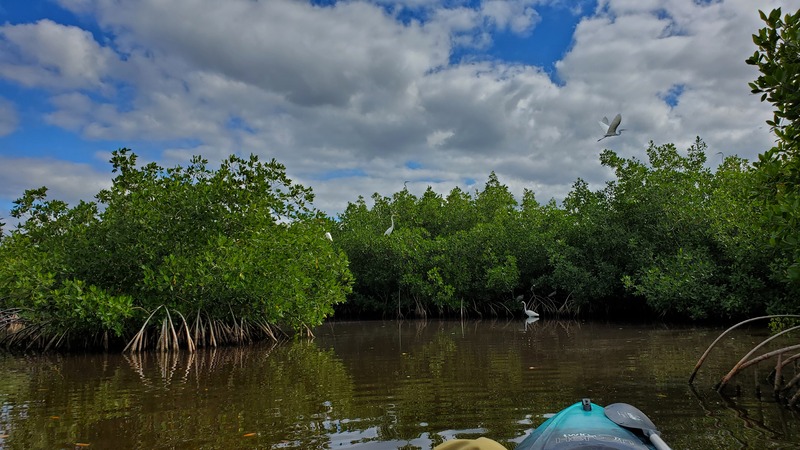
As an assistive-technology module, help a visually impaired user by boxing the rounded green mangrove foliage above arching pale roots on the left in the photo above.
[0,149,352,350]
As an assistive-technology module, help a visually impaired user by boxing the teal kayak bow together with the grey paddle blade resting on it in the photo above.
[516,399,669,450]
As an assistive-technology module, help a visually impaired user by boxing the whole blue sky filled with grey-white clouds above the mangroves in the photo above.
[0,0,800,229]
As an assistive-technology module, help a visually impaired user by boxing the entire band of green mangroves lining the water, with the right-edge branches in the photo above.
[0,9,800,352]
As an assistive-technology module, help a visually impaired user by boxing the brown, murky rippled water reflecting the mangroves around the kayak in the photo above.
[0,320,800,450]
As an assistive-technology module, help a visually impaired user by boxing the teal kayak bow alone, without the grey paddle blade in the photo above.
[516,399,656,450]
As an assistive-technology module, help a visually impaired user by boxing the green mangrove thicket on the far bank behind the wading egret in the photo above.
[339,138,788,320]
